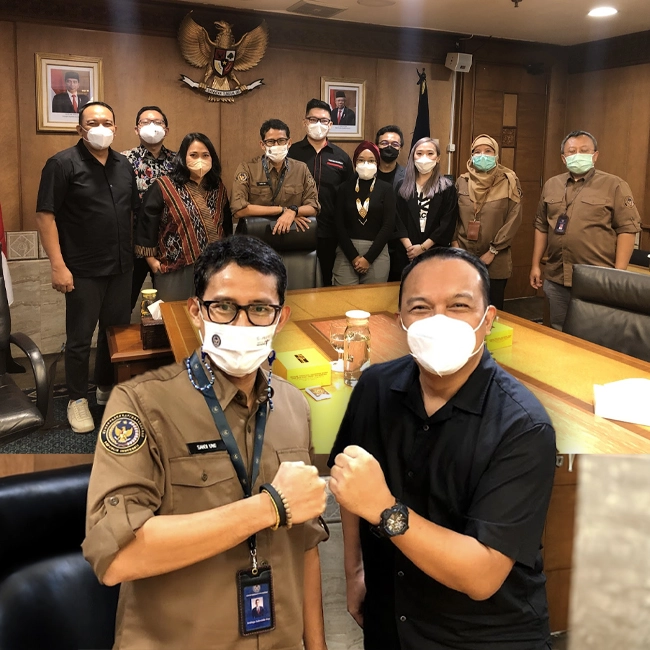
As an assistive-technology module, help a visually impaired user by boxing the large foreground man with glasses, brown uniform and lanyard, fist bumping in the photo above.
[83,236,327,650]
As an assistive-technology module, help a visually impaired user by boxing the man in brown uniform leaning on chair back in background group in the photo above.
[230,119,320,235]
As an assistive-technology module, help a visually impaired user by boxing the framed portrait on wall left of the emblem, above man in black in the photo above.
[36,52,104,132]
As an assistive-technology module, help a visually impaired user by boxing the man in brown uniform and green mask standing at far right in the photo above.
[530,131,641,330]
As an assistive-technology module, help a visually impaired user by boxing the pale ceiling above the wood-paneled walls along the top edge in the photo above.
[184,0,650,45]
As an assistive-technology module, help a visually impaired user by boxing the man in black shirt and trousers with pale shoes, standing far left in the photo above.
[36,102,139,433]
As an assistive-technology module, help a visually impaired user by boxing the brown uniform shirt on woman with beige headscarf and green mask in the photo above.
[454,174,521,280]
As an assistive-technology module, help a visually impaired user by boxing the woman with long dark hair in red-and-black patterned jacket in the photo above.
[135,133,232,300]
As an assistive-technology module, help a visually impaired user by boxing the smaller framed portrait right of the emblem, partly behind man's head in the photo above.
[321,77,366,140]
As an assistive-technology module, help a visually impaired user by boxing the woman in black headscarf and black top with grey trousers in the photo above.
[332,141,395,285]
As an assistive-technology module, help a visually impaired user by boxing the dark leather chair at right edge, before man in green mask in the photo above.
[563,264,650,361]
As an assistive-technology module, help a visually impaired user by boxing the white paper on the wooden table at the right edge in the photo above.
[594,378,650,426]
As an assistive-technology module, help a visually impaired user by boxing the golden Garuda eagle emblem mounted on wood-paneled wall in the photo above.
[178,12,269,102]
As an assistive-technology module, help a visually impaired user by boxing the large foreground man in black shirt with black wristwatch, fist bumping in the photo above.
[330,248,555,650]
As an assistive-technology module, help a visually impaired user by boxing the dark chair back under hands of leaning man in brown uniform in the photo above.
[237,217,323,289]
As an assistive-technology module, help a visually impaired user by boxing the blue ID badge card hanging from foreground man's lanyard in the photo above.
[237,564,275,636]
